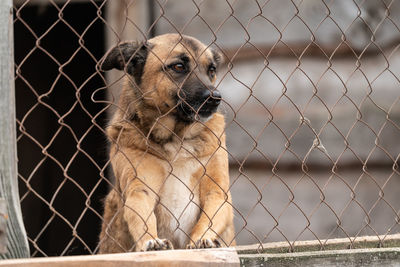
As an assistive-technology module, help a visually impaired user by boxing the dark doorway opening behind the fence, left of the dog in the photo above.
[14,1,107,256]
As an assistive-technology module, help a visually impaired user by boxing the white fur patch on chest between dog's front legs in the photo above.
[157,160,201,248]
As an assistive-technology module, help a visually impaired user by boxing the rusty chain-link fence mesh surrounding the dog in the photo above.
[14,0,400,256]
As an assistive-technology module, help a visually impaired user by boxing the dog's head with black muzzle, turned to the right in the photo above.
[101,34,222,123]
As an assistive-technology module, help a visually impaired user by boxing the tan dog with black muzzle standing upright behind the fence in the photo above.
[99,34,235,253]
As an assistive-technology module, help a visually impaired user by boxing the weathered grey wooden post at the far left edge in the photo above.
[0,0,29,258]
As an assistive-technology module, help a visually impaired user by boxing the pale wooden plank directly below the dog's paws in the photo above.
[0,248,239,267]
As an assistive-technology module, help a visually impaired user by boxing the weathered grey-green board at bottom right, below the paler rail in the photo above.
[240,248,400,267]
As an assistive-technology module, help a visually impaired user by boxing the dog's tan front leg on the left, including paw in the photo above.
[111,149,173,251]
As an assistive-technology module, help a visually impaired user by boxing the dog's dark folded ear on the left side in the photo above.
[100,42,149,83]
